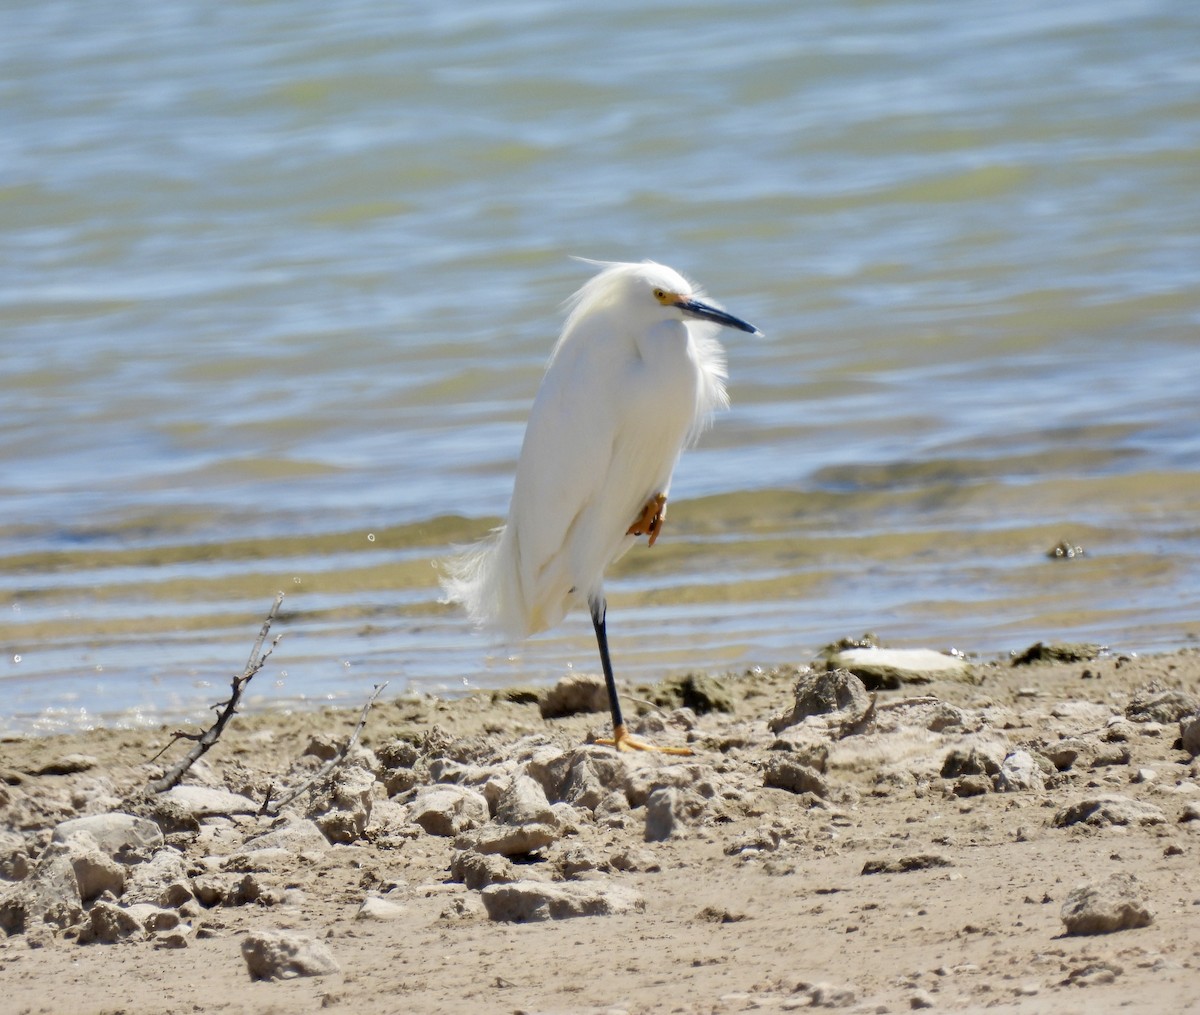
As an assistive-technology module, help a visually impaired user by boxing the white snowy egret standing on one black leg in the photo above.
[443,262,758,753]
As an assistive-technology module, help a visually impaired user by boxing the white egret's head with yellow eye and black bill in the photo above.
[571,258,760,335]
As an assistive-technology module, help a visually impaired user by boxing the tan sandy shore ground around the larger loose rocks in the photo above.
[0,650,1200,1015]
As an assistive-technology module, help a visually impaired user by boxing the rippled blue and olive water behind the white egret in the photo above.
[0,0,1200,729]
